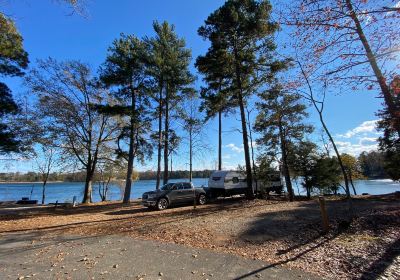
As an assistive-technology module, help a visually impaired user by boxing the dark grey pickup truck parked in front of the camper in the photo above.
[142,182,206,210]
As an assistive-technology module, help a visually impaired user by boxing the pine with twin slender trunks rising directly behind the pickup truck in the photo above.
[145,21,194,188]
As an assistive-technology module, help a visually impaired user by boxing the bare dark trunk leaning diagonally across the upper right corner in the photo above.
[346,0,400,137]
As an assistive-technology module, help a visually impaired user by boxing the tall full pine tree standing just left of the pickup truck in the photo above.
[101,34,152,203]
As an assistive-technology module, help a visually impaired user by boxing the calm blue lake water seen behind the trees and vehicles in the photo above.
[0,178,400,203]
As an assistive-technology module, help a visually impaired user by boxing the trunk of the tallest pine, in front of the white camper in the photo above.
[235,50,254,199]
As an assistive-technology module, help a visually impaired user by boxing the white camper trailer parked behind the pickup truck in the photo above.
[208,171,282,197]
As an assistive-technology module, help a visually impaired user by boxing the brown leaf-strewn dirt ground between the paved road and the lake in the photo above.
[0,193,400,279]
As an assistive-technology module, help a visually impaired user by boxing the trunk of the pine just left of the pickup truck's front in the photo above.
[123,89,136,204]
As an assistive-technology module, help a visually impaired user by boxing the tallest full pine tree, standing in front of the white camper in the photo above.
[198,0,283,198]
